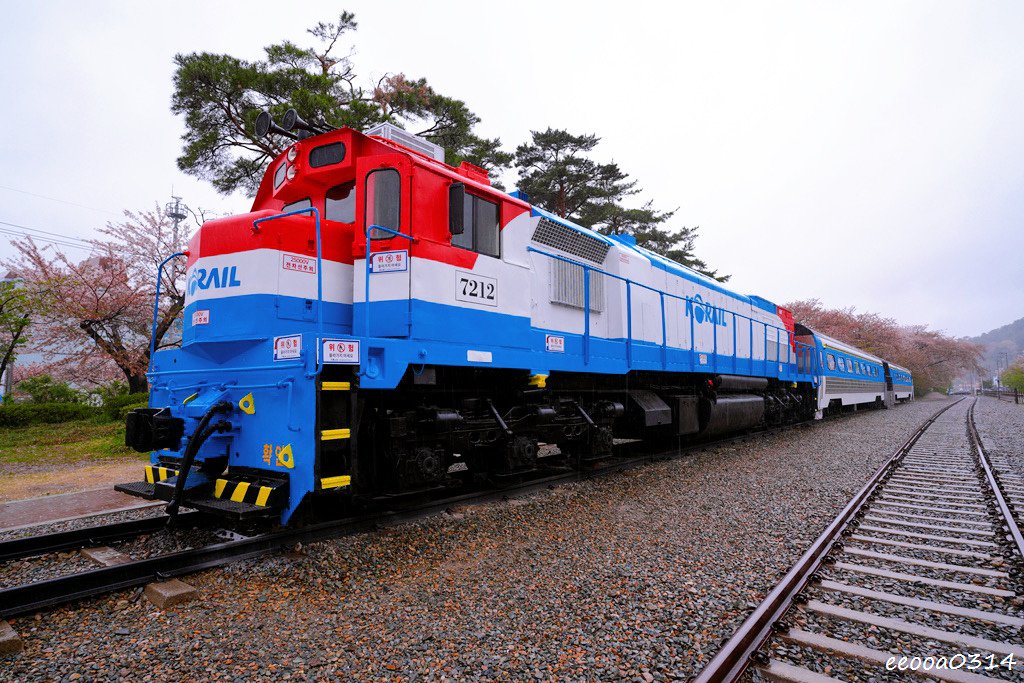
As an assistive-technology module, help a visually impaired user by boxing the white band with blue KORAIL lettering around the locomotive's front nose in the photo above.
[185,249,352,307]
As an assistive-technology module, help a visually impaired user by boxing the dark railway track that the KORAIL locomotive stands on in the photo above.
[0,422,809,618]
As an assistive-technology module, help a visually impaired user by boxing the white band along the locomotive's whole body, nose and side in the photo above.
[185,213,796,376]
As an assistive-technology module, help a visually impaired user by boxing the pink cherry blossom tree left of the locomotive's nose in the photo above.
[6,205,188,392]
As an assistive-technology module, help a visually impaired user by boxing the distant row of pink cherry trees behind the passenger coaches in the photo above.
[785,299,982,393]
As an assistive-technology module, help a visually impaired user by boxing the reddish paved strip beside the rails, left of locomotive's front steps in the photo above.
[0,486,154,530]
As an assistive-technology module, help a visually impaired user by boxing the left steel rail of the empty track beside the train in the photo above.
[693,398,964,683]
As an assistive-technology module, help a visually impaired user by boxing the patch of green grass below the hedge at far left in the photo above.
[0,420,148,465]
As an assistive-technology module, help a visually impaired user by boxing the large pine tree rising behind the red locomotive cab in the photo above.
[171,12,520,195]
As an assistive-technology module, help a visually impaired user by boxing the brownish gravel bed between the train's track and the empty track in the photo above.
[0,400,954,683]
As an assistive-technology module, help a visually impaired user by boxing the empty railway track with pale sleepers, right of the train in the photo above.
[695,398,1024,683]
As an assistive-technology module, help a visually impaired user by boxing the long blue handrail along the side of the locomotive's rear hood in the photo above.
[526,246,811,382]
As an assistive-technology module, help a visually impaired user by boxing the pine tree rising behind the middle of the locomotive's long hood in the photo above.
[515,128,729,282]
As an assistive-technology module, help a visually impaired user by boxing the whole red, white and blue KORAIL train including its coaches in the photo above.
[117,111,911,523]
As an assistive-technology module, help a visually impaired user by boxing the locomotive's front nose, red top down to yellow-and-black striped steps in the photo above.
[117,211,352,522]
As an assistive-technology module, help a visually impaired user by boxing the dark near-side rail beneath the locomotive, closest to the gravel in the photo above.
[0,413,813,618]
